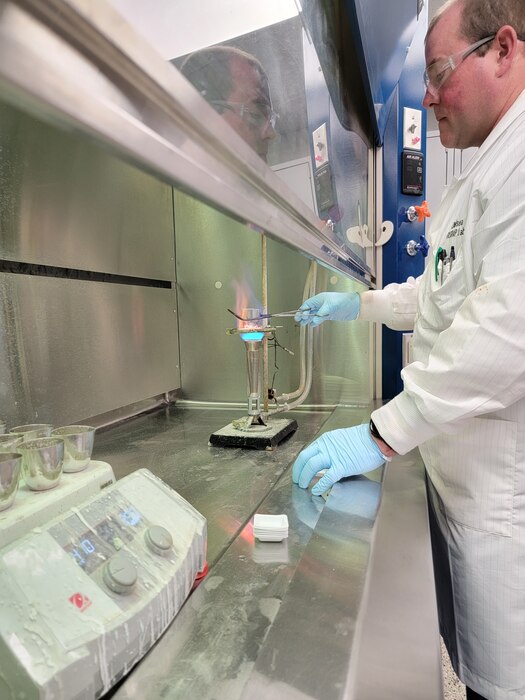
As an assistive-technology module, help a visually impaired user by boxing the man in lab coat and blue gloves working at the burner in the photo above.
[293,0,525,700]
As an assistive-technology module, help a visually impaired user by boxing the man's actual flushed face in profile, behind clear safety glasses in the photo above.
[423,5,495,148]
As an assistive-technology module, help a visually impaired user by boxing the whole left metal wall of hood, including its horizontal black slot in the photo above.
[0,100,180,427]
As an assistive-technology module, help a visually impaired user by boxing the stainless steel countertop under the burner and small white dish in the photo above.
[94,407,442,700]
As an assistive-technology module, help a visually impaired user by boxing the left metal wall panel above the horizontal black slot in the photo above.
[0,103,174,280]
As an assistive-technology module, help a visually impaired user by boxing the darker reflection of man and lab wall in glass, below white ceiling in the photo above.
[173,16,369,259]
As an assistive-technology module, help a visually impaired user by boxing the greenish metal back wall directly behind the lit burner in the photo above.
[175,193,371,405]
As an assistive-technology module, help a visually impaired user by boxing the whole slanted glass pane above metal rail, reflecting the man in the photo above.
[110,0,372,264]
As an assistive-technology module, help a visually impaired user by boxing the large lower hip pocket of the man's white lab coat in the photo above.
[422,417,517,537]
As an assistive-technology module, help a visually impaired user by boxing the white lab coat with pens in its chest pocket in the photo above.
[360,92,525,700]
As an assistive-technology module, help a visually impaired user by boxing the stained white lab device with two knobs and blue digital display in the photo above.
[0,462,206,700]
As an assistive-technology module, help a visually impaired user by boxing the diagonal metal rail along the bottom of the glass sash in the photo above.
[0,0,374,286]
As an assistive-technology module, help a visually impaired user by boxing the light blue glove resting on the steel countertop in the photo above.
[292,423,386,496]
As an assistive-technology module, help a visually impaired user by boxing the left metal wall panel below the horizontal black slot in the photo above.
[0,273,178,427]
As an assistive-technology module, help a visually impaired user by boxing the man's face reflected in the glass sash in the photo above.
[222,56,275,161]
